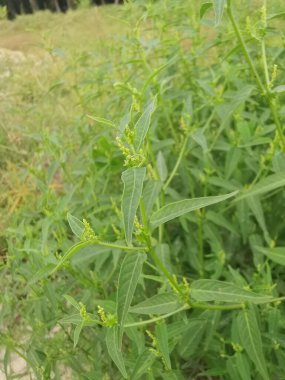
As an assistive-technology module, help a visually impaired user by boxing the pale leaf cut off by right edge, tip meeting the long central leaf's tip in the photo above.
[237,172,285,201]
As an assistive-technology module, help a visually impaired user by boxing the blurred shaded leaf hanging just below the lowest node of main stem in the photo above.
[178,320,207,360]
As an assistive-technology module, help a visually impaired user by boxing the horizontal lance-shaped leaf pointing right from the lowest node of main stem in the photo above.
[191,280,272,303]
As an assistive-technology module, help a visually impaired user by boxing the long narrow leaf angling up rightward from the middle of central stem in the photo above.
[150,191,238,228]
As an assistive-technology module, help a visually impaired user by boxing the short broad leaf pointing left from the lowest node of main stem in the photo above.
[130,293,179,315]
